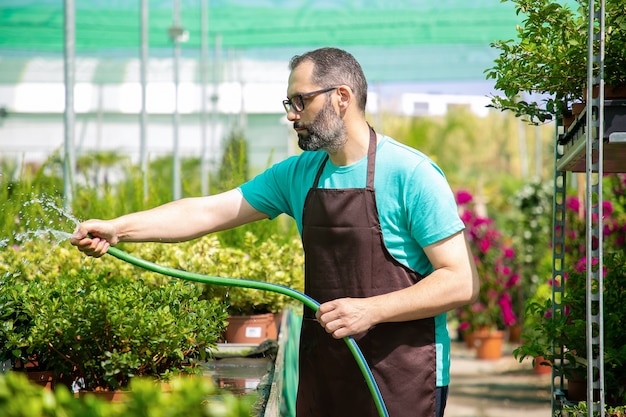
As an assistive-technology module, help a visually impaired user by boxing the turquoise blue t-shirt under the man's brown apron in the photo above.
[239,136,464,386]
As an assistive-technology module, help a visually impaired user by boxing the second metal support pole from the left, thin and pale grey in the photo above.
[139,0,148,201]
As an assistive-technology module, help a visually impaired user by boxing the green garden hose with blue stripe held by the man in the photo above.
[107,247,389,417]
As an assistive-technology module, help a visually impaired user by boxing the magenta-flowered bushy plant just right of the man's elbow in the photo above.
[456,191,519,331]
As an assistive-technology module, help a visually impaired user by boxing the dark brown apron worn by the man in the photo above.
[297,128,436,417]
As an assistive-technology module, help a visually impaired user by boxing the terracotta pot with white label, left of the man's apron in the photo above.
[225,313,280,344]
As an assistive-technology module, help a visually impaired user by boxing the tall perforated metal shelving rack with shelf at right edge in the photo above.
[552,0,626,417]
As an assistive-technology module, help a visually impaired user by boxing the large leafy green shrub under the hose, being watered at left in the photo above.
[3,243,227,390]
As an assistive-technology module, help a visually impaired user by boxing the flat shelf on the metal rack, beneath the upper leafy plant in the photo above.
[557,100,626,173]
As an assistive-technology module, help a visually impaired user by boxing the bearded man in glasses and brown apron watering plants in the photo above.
[72,48,479,417]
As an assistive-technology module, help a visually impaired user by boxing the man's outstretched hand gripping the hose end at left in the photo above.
[70,220,119,258]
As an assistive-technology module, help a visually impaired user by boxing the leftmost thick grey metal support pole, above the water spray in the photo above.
[63,0,76,209]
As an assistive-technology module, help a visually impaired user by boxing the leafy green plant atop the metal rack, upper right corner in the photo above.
[485,0,626,123]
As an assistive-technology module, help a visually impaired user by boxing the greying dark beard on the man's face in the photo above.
[293,100,347,154]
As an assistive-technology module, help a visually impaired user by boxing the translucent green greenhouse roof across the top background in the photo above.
[0,0,521,84]
